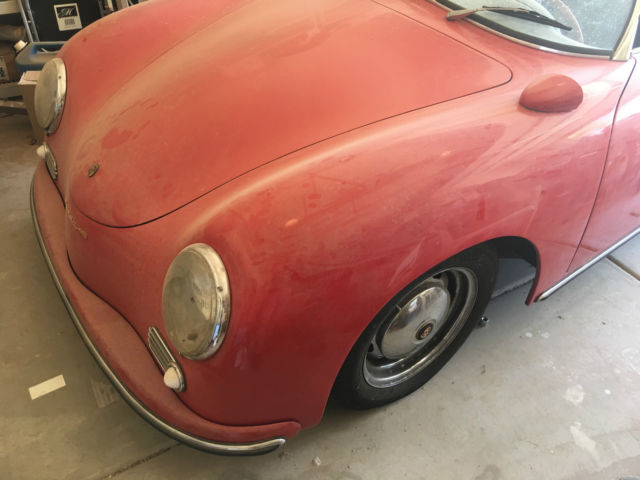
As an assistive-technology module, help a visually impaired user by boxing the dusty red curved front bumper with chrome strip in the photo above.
[31,163,300,455]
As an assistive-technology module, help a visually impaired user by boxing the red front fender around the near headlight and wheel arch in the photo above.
[69,65,624,426]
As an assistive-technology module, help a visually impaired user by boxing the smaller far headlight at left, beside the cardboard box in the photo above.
[35,58,67,133]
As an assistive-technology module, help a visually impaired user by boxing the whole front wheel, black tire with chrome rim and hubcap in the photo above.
[333,245,498,409]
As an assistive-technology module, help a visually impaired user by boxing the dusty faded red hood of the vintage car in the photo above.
[57,0,511,226]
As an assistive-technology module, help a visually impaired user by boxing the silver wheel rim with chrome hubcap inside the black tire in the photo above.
[363,268,478,388]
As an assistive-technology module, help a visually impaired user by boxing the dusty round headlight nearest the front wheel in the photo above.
[162,243,231,360]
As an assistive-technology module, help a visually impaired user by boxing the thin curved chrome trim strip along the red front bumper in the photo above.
[31,181,286,455]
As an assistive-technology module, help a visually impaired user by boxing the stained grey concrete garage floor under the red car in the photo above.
[0,116,640,480]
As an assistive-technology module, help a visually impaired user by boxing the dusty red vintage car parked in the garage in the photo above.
[32,0,640,454]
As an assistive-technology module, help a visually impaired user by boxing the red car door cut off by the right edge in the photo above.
[569,29,640,271]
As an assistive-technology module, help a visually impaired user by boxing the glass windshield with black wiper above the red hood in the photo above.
[437,0,635,55]
